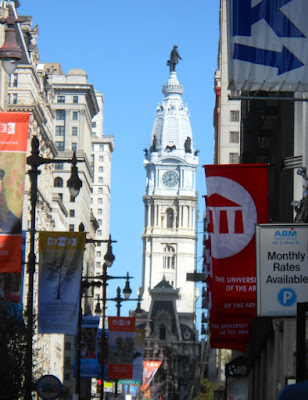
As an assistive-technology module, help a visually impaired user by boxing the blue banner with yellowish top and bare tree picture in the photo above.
[38,232,86,335]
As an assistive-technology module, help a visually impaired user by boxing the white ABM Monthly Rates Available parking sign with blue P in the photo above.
[256,224,308,317]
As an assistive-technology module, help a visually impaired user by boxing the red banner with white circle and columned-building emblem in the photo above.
[204,164,268,317]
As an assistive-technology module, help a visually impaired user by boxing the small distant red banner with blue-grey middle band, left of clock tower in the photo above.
[108,317,136,379]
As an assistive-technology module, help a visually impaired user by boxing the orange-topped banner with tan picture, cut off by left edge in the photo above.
[0,112,30,273]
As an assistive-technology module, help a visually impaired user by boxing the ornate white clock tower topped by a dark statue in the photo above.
[141,56,198,320]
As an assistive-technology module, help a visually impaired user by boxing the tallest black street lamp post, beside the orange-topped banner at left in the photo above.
[25,136,83,400]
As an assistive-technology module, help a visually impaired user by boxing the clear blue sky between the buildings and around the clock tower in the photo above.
[17,0,219,324]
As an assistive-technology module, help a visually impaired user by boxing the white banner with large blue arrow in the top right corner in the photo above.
[226,0,308,92]
